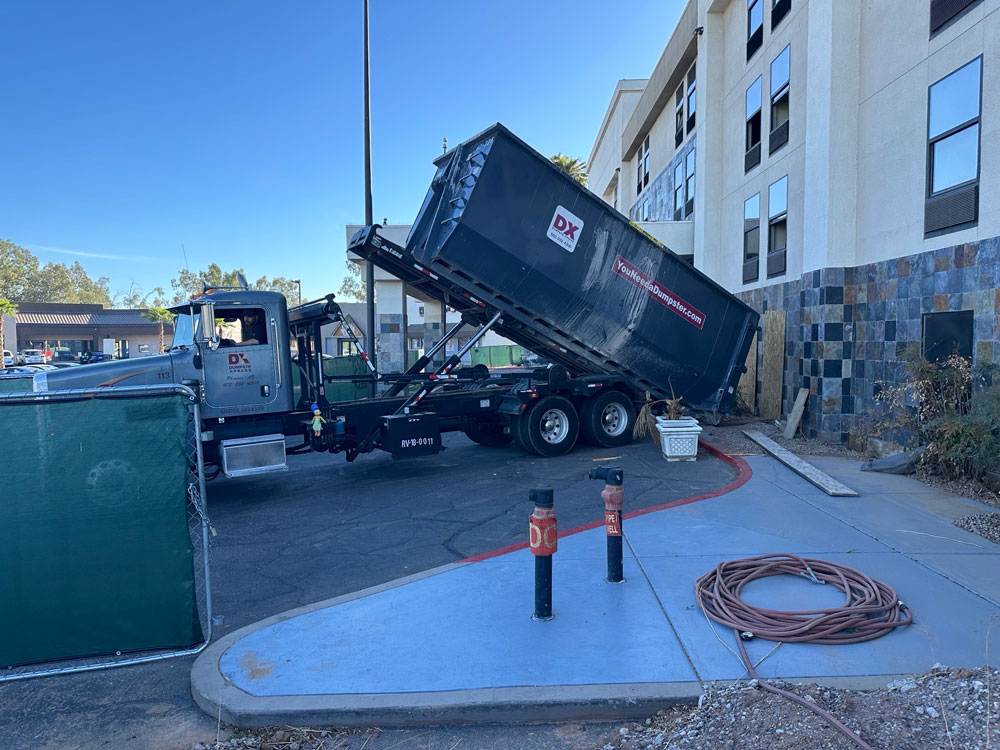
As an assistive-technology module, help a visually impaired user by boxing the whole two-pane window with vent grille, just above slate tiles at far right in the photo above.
[924,57,983,233]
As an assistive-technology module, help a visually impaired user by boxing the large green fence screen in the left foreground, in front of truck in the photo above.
[0,390,202,666]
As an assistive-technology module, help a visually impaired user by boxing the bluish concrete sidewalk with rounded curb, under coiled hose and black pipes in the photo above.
[191,457,1000,726]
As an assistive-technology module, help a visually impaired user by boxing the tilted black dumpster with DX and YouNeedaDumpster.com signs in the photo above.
[360,124,758,411]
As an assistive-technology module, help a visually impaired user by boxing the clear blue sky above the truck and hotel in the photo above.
[0,0,683,306]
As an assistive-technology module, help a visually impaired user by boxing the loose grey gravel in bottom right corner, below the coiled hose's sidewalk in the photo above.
[595,667,1000,750]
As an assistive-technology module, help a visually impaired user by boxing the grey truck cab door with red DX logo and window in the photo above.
[204,306,279,416]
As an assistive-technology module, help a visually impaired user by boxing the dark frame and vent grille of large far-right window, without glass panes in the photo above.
[924,54,986,237]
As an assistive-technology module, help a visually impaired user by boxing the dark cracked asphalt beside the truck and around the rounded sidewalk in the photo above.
[0,433,736,750]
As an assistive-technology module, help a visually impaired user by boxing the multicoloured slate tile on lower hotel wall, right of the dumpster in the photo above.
[737,237,1000,442]
